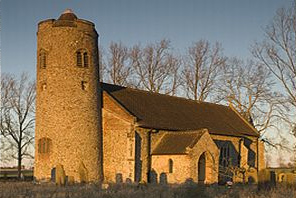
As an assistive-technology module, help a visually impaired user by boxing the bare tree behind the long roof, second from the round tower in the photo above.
[131,40,181,95]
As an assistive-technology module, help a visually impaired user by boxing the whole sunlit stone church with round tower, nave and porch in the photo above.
[34,10,265,184]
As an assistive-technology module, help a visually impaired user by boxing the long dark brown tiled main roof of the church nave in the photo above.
[102,83,259,136]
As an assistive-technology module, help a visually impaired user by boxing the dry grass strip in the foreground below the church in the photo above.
[0,182,296,198]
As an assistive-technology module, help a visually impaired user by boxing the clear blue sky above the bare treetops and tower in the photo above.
[0,0,292,77]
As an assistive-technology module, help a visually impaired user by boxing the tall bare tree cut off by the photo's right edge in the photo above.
[253,1,296,108]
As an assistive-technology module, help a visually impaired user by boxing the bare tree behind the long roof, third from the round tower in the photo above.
[182,40,226,101]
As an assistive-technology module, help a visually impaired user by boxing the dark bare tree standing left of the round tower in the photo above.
[0,74,35,178]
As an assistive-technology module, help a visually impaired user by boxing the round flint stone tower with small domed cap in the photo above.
[34,10,102,182]
